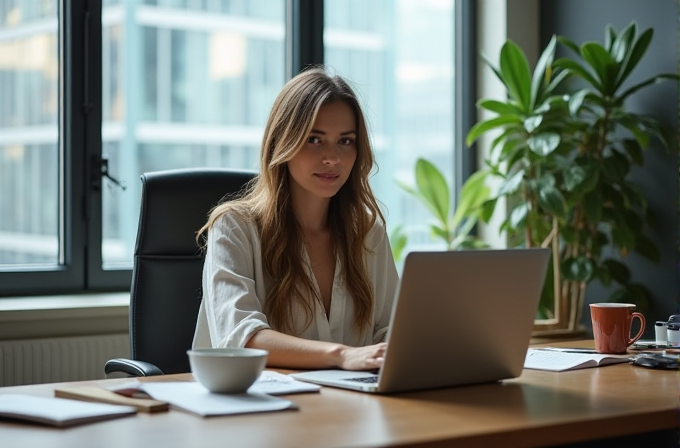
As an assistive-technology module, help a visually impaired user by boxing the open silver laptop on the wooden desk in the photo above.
[291,249,550,393]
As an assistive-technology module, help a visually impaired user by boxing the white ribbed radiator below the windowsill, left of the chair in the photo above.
[0,334,130,386]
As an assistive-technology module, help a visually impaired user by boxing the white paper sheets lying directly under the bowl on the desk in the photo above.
[140,381,297,417]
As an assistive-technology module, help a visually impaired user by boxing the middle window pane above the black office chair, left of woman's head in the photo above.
[102,0,285,268]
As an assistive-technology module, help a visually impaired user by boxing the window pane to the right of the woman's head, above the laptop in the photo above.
[324,0,454,254]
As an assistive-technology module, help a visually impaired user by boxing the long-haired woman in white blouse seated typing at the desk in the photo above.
[194,67,398,370]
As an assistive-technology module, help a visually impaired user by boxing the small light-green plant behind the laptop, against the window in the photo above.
[391,158,491,260]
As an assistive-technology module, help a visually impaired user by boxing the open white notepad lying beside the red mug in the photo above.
[524,348,629,372]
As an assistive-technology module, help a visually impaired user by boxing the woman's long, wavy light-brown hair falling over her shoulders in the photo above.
[198,66,385,334]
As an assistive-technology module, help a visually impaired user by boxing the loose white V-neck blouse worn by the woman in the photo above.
[193,212,399,348]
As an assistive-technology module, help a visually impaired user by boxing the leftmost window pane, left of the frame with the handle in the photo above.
[0,0,63,267]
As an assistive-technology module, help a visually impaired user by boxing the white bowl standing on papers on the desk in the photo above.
[187,348,269,394]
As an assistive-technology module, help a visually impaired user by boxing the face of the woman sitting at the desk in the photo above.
[288,101,357,200]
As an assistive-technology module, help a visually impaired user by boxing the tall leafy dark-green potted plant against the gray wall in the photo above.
[467,22,677,334]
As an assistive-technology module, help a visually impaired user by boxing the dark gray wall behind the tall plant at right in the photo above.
[540,0,680,338]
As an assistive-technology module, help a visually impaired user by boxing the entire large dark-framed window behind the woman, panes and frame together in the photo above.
[0,0,470,295]
